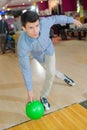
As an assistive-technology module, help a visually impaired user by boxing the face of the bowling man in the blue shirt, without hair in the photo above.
[23,20,40,38]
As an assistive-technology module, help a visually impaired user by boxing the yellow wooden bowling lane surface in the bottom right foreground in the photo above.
[8,104,87,130]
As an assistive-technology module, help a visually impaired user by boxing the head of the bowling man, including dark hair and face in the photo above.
[21,11,40,38]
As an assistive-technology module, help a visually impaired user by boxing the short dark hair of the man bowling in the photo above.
[21,11,39,27]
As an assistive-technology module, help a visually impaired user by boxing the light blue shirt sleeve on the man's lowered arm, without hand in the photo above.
[17,33,32,90]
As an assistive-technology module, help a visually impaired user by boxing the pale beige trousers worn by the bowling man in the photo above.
[29,53,64,97]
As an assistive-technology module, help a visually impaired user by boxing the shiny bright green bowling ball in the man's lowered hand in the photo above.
[26,100,44,120]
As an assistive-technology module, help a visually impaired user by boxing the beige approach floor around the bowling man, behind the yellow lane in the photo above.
[0,40,87,130]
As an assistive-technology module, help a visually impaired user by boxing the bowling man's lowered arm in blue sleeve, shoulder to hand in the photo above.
[17,33,33,100]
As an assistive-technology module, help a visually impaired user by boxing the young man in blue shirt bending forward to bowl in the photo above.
[18,11,82,110]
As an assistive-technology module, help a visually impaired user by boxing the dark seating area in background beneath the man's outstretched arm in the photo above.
[50,23,87,40]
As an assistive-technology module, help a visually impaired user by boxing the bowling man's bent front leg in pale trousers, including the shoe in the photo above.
[40,54,55,110]
